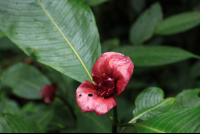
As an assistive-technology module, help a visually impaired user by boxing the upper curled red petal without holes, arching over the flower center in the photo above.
[92,52,134,95]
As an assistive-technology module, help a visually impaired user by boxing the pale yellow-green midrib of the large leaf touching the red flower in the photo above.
[37,0,94,83]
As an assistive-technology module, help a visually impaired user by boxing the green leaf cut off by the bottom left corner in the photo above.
[0,114,44,133]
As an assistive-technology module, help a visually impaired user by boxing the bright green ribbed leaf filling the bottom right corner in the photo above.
[135,107,200,133]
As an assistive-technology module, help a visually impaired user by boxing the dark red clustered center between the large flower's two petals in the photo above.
[96,73,116,98]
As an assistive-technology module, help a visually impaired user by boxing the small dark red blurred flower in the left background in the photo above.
[40,84,57,103]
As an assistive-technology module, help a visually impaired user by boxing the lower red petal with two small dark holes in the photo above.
[76,81,117,115]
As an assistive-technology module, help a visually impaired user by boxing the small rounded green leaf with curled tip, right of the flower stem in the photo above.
[130,87,175,122]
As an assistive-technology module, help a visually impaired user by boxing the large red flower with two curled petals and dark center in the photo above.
[76,52,134,115]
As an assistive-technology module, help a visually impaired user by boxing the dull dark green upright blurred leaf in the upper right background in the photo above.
[129,3,163,44]
